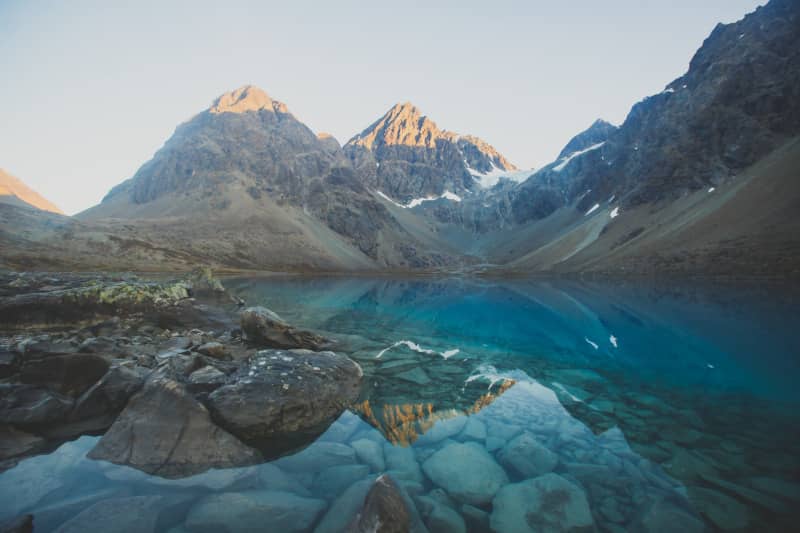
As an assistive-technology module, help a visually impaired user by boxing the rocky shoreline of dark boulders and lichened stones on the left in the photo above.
[0,269,363,478]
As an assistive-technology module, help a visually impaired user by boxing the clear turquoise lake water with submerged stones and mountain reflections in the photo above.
[0,278,800,532]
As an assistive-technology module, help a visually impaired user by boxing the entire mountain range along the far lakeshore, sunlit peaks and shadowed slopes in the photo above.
[0,0,800,275]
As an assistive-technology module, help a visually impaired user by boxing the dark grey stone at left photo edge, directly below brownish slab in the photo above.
[0,383,73,426]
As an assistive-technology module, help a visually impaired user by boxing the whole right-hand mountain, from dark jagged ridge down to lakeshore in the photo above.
[494,0,800,274]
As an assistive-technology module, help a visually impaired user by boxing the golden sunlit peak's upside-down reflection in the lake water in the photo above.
[354,379,516,446]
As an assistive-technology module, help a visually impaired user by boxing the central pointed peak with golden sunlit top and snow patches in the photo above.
[344,102,517,205]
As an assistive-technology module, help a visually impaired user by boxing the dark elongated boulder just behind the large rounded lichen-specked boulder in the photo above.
[239,307,330,350]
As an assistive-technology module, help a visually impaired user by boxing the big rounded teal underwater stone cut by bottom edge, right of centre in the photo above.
[490,473,594,533]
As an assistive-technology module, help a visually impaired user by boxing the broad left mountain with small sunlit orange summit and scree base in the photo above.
[78,86,460,270]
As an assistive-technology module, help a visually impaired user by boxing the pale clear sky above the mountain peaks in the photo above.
[0,0,764,213]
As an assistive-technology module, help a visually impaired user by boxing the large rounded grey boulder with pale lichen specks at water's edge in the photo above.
[206,350,363,453]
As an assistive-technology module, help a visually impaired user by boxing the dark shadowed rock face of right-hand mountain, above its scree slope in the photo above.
[514,0,800,222]
